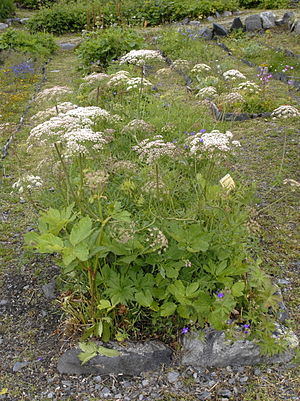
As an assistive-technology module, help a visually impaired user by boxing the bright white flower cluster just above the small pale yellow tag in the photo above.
[185,130,241,154]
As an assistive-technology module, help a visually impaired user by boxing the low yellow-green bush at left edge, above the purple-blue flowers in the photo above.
[0,28,57,57]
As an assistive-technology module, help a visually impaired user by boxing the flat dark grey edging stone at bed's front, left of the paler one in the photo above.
[57,341,172,376]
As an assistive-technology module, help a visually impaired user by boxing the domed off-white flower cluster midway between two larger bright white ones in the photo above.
[132,135,178,164]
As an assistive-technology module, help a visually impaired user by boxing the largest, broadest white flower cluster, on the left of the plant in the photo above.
[28,106,114,156]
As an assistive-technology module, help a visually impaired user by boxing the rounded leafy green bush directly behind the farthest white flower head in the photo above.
[77,27,143,67]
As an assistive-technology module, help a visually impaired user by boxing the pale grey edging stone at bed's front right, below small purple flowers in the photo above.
[180,326,296,367]
